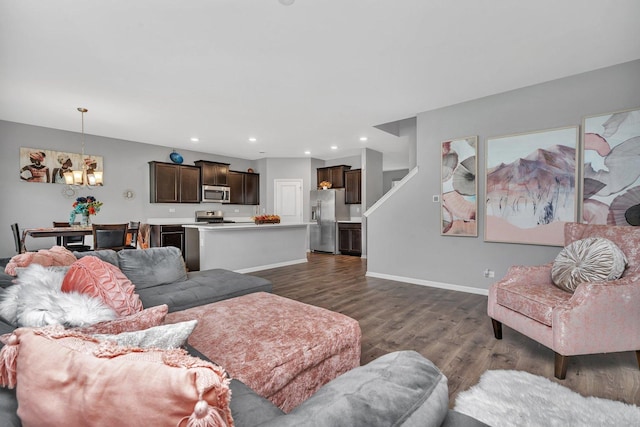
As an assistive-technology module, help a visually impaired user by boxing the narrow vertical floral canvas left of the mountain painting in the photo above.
[440,136,478,237]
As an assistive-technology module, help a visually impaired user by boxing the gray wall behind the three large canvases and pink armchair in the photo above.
[367,60,640,293]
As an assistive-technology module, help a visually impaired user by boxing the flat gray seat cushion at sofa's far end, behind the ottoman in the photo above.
[134,268,272,312]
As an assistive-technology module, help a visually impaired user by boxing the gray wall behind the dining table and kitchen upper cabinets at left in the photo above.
[0,121,264,257]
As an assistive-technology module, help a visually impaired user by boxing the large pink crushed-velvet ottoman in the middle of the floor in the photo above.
[166,292,361,412]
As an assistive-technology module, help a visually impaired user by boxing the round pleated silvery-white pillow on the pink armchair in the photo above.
[551,237,627,293]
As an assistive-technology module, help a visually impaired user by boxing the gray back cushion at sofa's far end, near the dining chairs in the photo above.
[118,246,187,290]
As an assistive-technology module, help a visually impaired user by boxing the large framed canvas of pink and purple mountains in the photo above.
[485,126,578,246]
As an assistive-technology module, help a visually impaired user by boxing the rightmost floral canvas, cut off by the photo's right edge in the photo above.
[582,109,640,226]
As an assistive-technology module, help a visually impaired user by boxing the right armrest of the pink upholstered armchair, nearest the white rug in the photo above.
[552,276,640,356]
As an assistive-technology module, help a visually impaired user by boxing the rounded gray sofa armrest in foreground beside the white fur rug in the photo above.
[260,351,449,427]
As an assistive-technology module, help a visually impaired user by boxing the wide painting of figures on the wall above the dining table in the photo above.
[19,147,103,184]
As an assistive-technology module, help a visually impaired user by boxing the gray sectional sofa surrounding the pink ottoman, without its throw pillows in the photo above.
[0,248,485,427]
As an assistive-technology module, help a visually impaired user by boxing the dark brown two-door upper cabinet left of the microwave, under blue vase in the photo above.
[149,161,200,203]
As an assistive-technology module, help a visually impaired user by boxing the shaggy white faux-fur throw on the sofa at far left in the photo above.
[0,264,117,327]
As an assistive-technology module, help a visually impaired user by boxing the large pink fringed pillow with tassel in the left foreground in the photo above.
[3,326,233,427]
